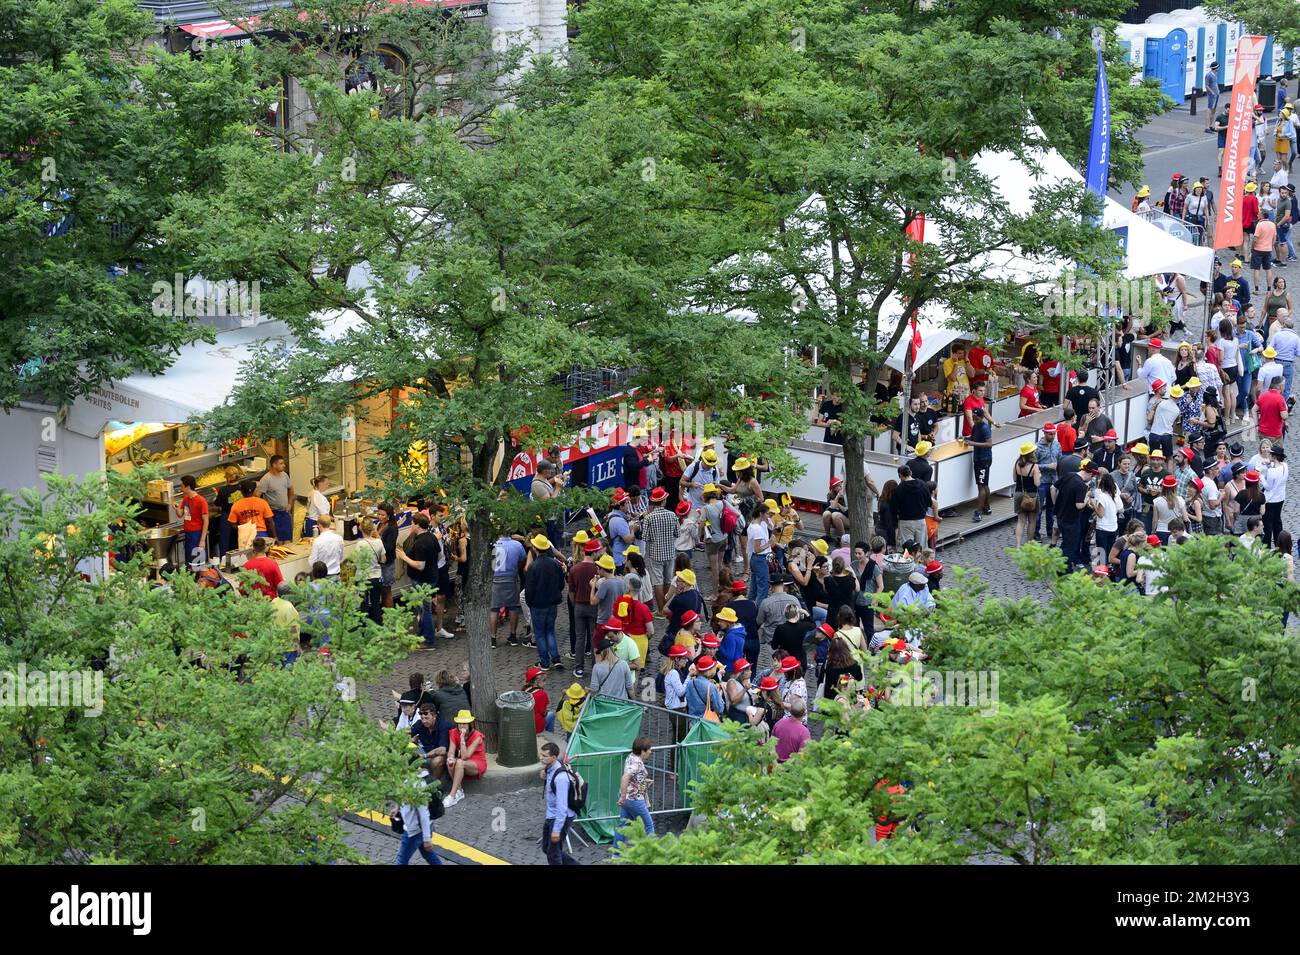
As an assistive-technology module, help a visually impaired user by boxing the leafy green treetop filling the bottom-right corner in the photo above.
[627,538,1300,864]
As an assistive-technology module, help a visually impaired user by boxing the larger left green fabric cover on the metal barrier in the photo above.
[568,696,650,842]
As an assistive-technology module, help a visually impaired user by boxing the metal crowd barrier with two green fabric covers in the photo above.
[568,698,722,838]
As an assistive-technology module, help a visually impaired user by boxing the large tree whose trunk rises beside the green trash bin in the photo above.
[161,0,800,742]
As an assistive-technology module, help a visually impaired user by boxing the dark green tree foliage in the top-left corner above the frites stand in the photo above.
[0,0,266,409]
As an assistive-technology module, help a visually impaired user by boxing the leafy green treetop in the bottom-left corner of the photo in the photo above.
[0,476,415,864]
